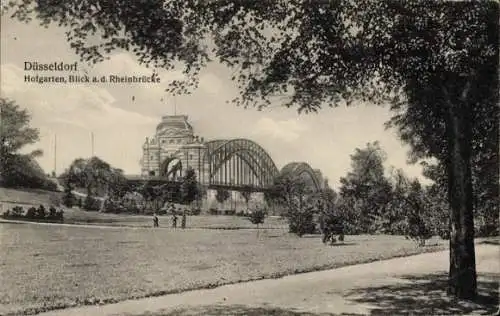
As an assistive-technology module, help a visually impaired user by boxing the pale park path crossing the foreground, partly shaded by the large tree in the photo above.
[40,245,500,316]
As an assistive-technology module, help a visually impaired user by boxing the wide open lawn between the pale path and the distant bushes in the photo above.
[0,223,446,314]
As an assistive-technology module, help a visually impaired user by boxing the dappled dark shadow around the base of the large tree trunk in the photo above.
[345,273,500,315]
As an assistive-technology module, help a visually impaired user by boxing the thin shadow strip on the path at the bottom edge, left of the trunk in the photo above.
[124,305,333,316]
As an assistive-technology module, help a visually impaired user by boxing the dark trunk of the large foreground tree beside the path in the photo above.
[447,83,477,299]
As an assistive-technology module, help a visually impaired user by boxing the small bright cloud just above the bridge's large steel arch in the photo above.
[254,117,307,142]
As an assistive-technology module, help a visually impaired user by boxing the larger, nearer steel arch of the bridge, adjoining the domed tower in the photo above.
[203,139,279,190]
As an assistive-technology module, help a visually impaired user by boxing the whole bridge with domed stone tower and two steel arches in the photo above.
[130,115,325,192]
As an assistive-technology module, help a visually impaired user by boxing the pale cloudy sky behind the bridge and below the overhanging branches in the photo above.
[0,16,421,188]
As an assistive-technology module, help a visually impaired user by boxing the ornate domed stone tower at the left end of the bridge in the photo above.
[141,115,203,180]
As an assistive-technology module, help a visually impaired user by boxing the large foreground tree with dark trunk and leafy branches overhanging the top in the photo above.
[4,0,499,298]
